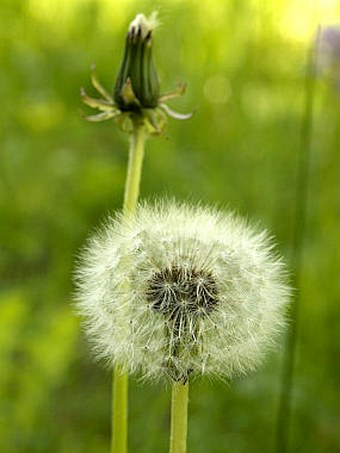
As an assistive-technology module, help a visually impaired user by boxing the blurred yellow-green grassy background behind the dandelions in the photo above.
[0,0,340,453]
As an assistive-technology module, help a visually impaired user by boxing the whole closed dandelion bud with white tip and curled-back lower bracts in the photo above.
[81,13,192,135]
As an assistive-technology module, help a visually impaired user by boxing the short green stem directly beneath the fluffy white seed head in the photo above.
[170,382,189,453]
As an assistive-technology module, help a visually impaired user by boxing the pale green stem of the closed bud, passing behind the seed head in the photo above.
[111,120,147,453]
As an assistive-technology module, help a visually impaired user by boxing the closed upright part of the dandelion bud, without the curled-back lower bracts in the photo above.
[114,14,160,111]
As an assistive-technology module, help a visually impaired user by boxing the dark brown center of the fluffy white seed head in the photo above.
[146,266,218,319]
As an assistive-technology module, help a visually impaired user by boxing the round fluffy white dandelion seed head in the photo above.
[76,202,290,381]
